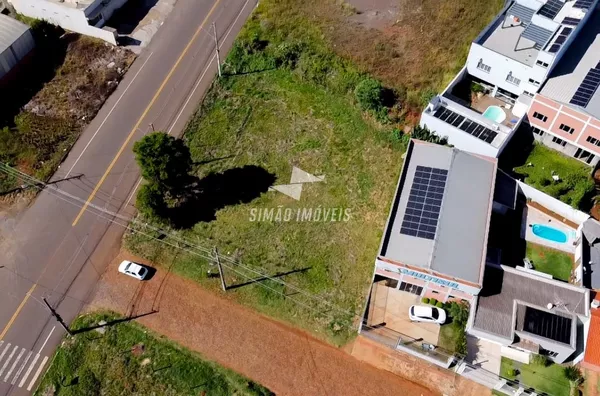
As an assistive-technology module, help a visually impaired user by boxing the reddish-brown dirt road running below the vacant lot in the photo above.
[88,255,436,396]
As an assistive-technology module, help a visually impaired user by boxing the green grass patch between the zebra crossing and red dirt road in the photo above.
[35,313,272,396]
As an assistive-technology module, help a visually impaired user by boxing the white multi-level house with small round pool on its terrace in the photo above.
[420,0,599,158]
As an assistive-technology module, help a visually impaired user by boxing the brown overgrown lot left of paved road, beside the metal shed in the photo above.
[0,18,135,192]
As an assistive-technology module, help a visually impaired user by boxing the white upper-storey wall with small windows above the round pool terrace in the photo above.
[467,43,543,95]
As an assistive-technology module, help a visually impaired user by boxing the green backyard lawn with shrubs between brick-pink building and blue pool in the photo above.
[514,144,594,211]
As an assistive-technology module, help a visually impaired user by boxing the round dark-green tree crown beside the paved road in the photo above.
[133,132,192,191]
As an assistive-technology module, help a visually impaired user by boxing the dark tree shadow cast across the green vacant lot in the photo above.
[168,165,276,229]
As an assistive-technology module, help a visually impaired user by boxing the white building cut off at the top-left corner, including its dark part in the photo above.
[9,0,127,44]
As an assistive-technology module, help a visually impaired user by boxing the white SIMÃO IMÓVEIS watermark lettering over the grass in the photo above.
[250,205,352,223]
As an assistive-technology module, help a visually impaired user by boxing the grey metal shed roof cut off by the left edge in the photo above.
[0,14,35,78]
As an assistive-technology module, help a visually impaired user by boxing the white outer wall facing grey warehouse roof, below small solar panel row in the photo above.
[420,112,500,158]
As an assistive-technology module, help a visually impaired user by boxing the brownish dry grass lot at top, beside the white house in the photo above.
[322,0,504,108]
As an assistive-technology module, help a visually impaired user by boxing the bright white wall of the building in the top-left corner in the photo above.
[9,0,117,45]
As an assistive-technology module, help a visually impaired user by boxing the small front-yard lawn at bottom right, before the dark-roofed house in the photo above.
[500,357,570,396]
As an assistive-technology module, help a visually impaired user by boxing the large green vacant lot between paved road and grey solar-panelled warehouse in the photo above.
[125,0,500,344]
